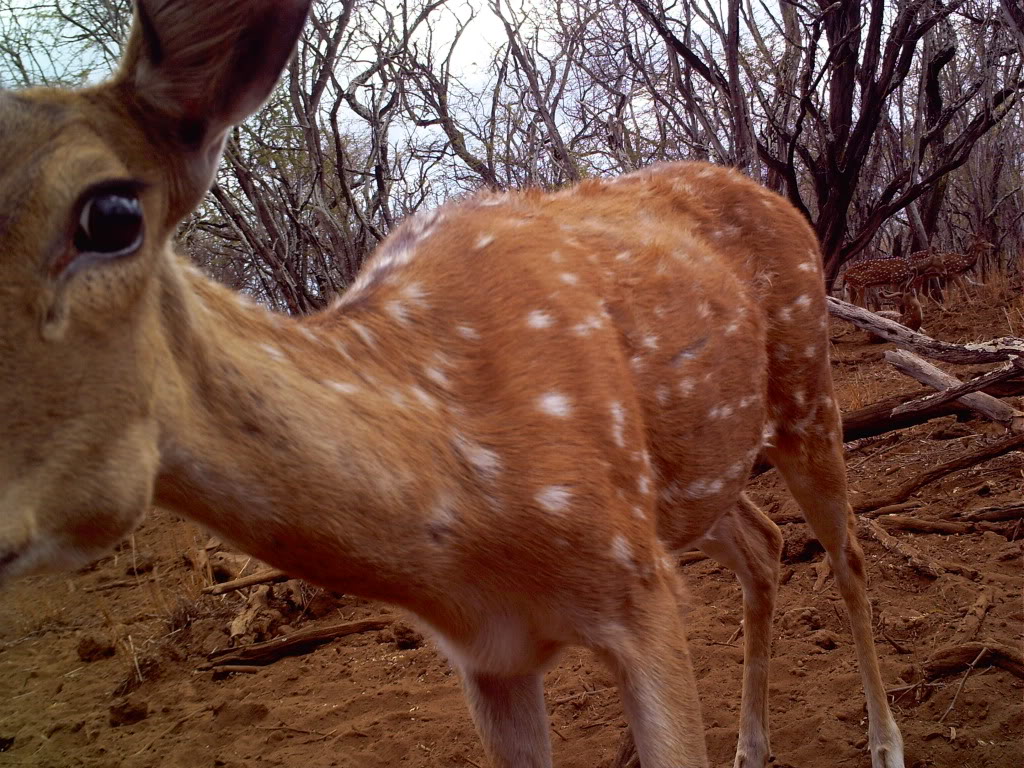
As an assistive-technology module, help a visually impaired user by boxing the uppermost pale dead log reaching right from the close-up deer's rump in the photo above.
[828,296,1024,365]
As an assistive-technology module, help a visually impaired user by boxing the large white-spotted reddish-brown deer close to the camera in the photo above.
[0,0,904,768]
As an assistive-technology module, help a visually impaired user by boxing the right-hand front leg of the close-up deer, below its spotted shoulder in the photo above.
[590,565,708,768]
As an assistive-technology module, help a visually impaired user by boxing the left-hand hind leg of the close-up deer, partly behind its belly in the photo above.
[697,495,782,768]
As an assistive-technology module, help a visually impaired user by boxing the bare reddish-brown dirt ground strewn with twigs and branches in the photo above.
[0,290,1024,768]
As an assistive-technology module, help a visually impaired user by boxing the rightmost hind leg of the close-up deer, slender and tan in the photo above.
[768,409,903,768]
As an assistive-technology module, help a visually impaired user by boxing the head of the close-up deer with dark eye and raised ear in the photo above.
[0,0,309,575]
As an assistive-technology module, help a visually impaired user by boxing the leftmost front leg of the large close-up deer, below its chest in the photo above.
[462,670,551,768]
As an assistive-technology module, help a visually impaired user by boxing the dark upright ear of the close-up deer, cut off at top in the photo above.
[118,0,310,207]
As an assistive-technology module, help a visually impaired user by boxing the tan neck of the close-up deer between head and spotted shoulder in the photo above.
[147,260,440,603]
